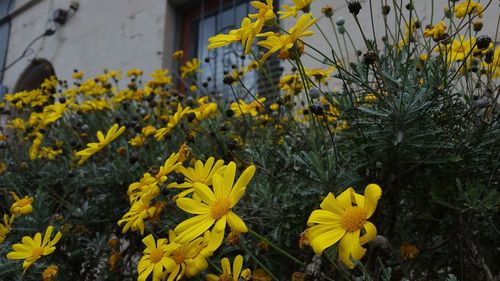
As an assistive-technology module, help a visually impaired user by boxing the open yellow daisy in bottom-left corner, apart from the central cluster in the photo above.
[7,225,62,271]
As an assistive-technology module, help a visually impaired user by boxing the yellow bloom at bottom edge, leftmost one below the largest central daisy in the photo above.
[137,234,175,281]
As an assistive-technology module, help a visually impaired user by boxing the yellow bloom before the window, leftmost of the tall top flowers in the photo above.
[207,18,260,54]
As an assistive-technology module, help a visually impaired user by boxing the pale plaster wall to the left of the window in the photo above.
[3,0,168,89]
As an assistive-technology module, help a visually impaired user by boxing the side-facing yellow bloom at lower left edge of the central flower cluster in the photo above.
[118,193,156,235]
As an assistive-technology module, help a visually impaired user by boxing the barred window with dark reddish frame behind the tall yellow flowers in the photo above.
[181,0,280,100]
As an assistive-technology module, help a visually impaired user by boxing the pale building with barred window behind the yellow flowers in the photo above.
[0,0,500,93]
